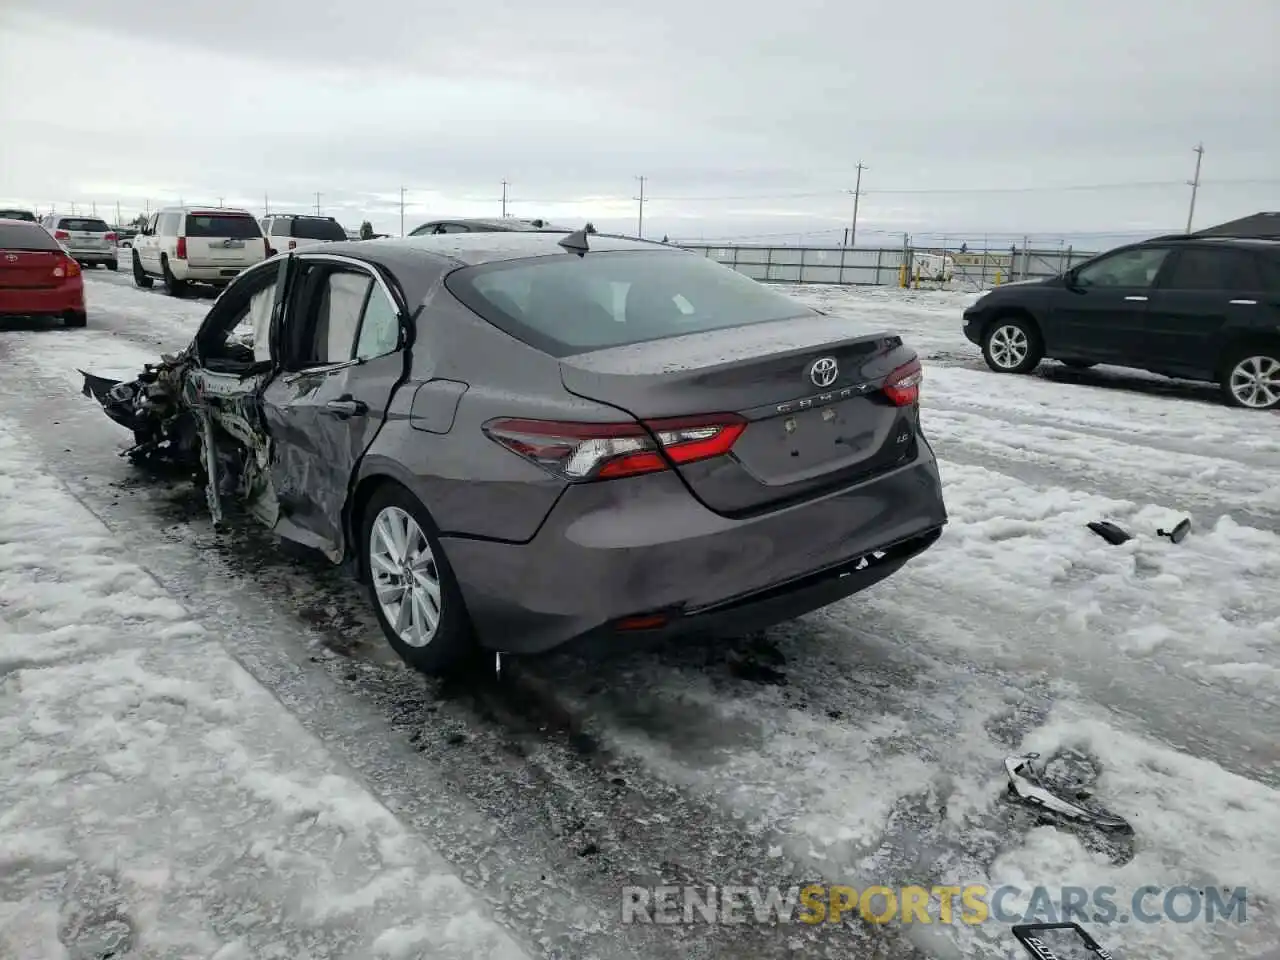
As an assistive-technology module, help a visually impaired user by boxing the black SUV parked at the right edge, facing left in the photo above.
[964,234,1280,410]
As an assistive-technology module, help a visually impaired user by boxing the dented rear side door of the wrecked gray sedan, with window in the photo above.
[262,255,406,556]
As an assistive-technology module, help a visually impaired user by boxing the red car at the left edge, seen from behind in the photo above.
[0,220,86,326]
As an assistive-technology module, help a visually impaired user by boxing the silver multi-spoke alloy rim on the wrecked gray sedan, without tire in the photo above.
[369,506,443,648]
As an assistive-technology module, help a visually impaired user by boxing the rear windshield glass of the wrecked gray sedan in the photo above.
[445,251,812,357]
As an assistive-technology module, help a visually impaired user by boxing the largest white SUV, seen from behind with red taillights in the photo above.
[133,206,269,297]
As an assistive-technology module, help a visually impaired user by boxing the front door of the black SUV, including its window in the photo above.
[1047,247,1169,366]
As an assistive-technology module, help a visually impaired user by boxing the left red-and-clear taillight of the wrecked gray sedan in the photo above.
[484,413,746,483]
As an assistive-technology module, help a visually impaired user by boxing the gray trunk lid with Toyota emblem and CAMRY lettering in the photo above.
[561,316,916,516]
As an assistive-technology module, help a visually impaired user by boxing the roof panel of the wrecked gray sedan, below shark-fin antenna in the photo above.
[316,229,673,266]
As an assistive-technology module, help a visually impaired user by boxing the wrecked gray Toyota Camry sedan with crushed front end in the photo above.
[84,232,946,672]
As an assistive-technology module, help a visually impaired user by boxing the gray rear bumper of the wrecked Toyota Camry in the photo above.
[443,444,947,653]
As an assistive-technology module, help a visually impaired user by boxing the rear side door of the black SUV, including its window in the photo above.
[1144,244,1266,376]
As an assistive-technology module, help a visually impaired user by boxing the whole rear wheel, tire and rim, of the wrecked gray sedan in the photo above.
[358,483,475,675]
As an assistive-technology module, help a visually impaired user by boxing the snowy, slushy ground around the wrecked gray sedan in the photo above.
[0,274,1280,959]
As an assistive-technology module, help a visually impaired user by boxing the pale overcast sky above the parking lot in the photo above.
[0,0,1280,244]
